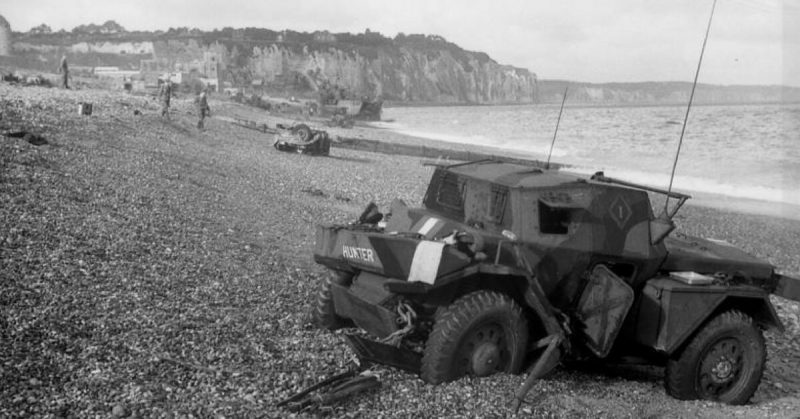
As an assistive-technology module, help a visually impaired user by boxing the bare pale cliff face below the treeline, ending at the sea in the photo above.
[238,45,536,103]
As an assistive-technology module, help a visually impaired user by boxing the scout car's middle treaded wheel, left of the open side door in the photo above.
[420,291,528,384]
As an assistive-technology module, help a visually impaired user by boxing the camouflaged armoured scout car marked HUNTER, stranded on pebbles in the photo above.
[314,161,800,404]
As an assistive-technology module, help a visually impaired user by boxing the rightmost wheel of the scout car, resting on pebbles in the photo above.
[665,310,767,404]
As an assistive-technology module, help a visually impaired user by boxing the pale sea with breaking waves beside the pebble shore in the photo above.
[381,104,800,218]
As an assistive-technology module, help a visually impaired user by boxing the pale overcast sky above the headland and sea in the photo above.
[0,0,800,86]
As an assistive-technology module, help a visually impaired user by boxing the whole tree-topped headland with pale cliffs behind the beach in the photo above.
[6,29,536,104]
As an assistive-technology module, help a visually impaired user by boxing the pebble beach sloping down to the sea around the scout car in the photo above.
[0,84,800,418]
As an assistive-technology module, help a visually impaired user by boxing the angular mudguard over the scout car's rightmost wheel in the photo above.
[635,277,783,355]
